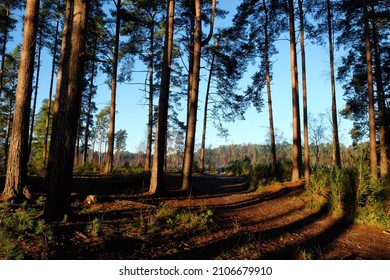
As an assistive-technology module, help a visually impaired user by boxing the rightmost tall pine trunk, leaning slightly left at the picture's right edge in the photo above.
[371,4,388,178]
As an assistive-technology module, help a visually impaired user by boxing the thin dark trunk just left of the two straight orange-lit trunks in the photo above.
[263,0,276,175]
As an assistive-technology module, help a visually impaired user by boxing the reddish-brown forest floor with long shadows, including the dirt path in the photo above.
[22,174,390,260]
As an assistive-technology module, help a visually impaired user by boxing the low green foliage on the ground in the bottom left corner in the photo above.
[0,199,54,259]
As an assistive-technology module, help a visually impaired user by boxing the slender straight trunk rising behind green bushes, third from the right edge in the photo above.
[326,0,341,167]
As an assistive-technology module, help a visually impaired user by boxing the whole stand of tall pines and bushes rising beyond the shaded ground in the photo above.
[0,0,390,260]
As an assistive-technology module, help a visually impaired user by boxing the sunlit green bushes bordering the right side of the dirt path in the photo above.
[307,158,390,228]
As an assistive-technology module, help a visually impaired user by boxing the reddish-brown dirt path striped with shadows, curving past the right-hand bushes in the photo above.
[161,175,390,259]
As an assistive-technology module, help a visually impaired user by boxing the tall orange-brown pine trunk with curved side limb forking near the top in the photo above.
[182,0,216,190]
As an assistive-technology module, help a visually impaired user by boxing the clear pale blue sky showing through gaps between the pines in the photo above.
[8,0,351,152]
